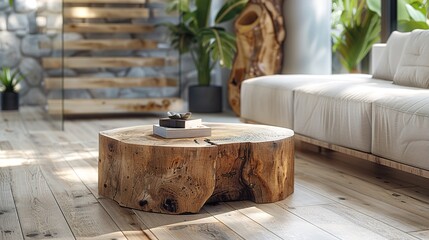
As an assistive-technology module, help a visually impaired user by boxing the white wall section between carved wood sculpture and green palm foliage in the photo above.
[282,0,332,74]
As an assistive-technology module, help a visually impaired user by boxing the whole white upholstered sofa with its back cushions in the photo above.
[241,30,429,177]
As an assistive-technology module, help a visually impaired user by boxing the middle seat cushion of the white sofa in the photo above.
[294,79,416,152]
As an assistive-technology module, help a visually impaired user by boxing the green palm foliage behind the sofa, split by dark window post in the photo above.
[332,0,429,72]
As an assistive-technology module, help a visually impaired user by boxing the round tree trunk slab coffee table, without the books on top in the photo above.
[98,123,294,214]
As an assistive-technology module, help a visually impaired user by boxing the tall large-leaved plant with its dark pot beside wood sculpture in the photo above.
[165,0,247,112]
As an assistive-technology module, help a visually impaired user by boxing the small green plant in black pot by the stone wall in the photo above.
[0,67,23,110]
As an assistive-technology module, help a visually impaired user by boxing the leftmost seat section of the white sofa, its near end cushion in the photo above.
[240,74,371,129]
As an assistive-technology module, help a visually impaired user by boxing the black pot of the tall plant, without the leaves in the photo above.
[189,86,222,113]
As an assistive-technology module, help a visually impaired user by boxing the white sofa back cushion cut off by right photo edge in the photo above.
[393,30,429,88]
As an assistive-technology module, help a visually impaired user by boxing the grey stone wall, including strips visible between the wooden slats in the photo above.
[0,0,195,106]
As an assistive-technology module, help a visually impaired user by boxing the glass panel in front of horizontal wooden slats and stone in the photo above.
[52,0,182,117]
